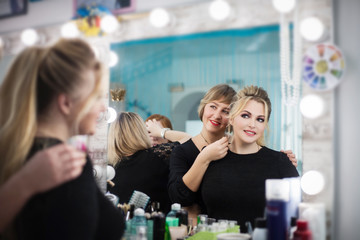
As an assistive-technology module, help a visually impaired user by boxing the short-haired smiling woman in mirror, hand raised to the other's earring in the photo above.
[148,84,297,224]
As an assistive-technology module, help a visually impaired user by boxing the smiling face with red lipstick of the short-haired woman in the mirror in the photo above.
[202,100,230,134]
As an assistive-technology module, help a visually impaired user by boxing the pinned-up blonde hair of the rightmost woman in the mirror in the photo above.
[229,85,271,146]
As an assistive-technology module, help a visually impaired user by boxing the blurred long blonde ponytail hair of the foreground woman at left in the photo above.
[0,39,102,185]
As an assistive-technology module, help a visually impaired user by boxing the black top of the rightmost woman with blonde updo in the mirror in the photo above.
[200,147,299,232]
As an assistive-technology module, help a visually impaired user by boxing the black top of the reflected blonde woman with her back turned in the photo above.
[108,142,179,213]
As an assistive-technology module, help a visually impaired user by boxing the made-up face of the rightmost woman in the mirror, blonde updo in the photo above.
[230,100,266,144]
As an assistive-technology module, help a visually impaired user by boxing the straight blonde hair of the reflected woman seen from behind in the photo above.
[108,112,151,166]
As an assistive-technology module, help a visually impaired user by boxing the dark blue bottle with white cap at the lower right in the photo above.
[266,179,289,240]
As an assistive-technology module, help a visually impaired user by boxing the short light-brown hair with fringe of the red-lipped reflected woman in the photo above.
[198,84,236,121]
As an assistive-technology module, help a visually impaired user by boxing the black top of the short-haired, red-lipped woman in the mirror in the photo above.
[168,139,206,213]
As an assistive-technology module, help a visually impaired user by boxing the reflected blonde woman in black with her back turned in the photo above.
[108,112,189,213]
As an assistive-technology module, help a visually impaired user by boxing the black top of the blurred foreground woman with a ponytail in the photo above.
[15,138,125,240]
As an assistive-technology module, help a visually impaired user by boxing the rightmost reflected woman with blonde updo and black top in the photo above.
[201,86,299,232]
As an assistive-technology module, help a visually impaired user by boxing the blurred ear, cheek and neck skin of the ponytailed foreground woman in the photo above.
[75,71,106,135]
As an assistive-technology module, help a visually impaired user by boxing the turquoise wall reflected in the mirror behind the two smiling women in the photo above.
[110,25,301,156]
